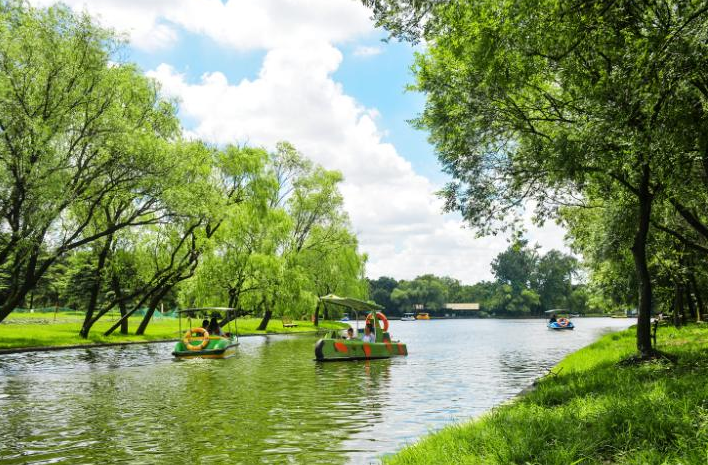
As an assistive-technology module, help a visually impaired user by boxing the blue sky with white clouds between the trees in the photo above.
[32,0,567,284]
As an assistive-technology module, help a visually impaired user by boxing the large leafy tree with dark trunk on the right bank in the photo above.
[364,0,708,357]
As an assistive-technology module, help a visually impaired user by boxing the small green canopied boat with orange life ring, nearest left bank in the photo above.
[172,307,239,359]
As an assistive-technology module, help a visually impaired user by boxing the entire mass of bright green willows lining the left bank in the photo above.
[0,0,367,337]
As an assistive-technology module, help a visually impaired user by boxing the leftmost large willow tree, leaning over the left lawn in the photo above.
[0,1,178,321]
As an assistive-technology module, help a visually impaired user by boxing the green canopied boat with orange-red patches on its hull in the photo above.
[315,294,408,362]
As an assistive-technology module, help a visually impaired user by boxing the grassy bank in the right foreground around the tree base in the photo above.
[384,325,708,465]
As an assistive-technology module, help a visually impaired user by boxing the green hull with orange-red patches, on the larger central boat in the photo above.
[315,338,408,362]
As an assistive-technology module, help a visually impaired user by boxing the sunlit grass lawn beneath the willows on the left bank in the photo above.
[0,312,347,349]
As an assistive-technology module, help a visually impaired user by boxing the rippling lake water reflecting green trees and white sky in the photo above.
[0,318,634,464]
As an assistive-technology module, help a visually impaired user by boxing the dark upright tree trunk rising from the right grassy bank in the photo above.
[632,164,653,358]
